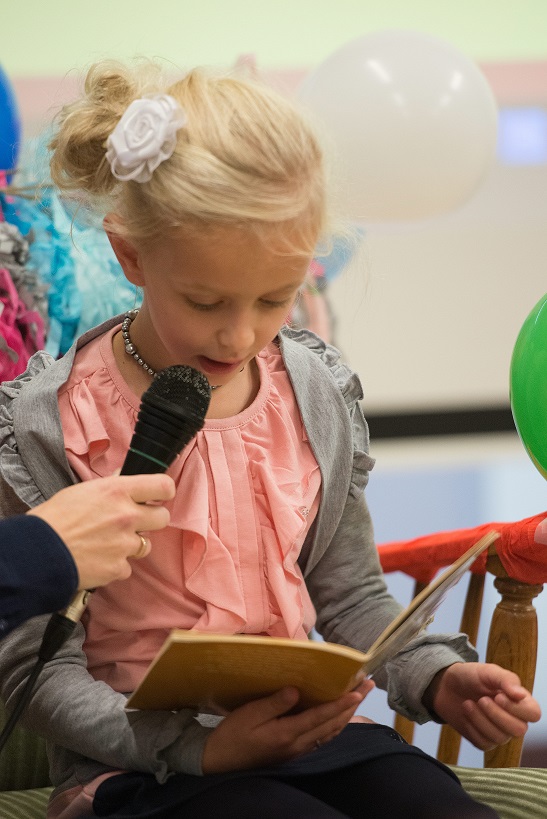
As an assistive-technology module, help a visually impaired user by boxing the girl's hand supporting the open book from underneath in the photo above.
[202,680,374,774]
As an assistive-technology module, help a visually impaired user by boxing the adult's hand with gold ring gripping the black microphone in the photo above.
[27,475,175,589]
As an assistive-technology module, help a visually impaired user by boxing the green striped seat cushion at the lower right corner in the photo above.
[452,766,547,819]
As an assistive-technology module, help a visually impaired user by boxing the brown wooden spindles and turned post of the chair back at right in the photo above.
[395,544,543,768]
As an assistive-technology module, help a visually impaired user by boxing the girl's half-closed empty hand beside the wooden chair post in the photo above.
[424,663,541,751]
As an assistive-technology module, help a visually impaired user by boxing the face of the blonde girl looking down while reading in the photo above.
[111,228,310,385]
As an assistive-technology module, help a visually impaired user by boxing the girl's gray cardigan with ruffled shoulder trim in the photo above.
[0,317,476,792]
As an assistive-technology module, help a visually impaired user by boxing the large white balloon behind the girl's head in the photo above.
[298,30,497,222]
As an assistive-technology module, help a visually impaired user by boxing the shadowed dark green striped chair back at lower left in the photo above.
[0,703,50,791]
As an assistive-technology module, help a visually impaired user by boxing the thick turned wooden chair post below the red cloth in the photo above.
[484,572,543,768]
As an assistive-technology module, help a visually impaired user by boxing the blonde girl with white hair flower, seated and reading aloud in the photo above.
[0,63,539,819]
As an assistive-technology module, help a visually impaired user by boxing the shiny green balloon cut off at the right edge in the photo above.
[510,295,547,478]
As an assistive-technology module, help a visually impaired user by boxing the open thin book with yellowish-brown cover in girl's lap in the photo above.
[127,532,499,713]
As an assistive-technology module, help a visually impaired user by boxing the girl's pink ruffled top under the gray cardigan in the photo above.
[59,328,321,692]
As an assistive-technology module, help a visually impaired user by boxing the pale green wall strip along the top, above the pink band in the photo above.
[4,0,547,77]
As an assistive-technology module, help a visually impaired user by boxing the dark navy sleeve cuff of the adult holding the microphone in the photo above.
[0,515,78,639]
